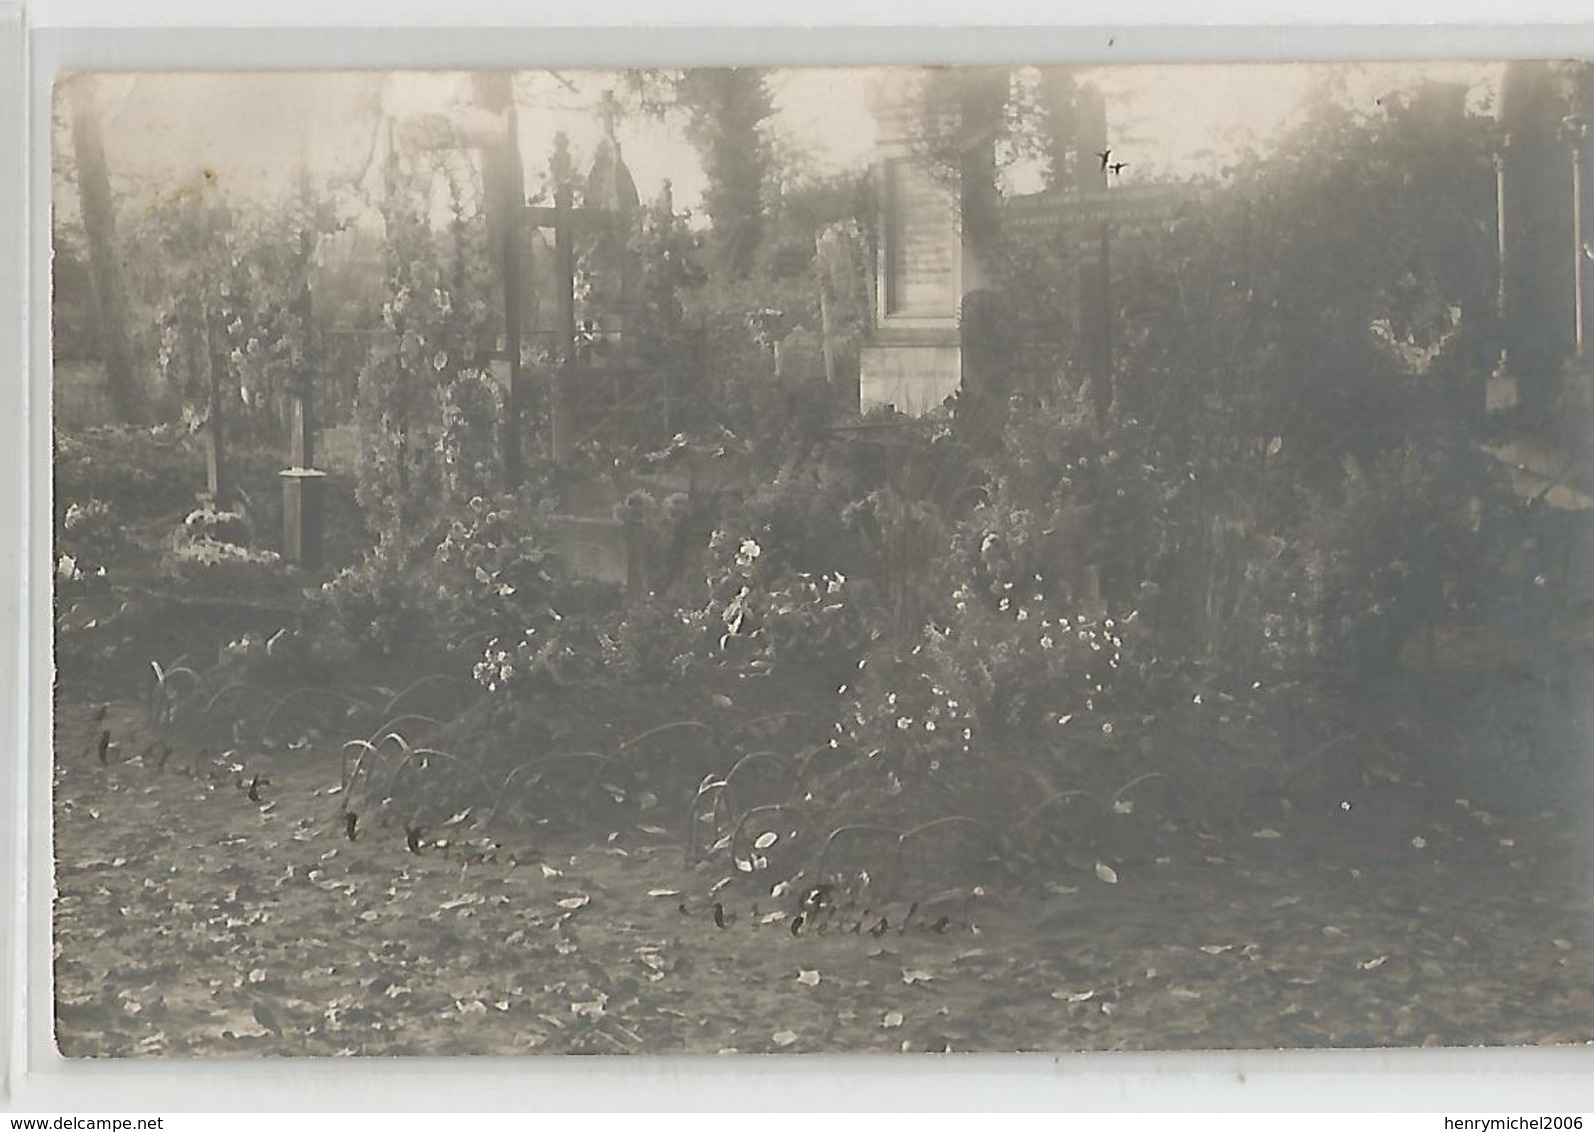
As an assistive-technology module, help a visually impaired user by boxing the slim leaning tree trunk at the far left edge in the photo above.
[70,77,147,424]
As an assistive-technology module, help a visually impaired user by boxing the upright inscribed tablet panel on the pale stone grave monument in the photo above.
[885,158,958,317]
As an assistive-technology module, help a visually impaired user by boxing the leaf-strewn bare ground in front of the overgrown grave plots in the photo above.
[54,694,1594,1057]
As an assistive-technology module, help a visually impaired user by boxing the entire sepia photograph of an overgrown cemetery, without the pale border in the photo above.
[49,61,1594,1059]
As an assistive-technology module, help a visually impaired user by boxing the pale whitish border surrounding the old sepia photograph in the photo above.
[9,0,1594,1127]
